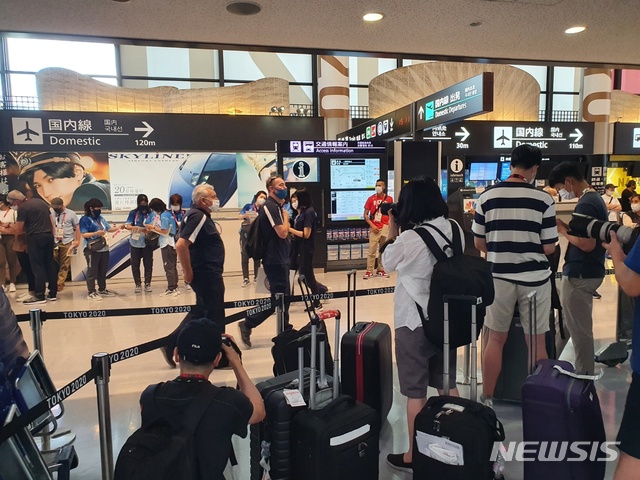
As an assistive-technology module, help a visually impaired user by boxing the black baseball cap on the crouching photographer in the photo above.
[177,318,222,365]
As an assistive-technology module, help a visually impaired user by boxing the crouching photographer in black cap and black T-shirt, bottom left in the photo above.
[140,318,265,480]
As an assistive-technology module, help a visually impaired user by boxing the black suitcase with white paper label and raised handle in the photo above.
[412,295,504,480]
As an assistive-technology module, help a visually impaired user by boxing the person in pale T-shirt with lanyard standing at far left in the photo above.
[51,197,80,292]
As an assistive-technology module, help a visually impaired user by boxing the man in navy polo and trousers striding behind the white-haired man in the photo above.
[238,175,291,348]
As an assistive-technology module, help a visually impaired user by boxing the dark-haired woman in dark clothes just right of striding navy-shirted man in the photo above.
[289,188,322,310]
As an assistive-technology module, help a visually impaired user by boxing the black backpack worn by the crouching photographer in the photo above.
[114,383,215,480]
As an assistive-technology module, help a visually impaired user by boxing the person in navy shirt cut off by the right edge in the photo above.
[603,232,640,480]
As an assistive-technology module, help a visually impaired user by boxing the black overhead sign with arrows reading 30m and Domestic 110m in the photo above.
[423,121,596,155]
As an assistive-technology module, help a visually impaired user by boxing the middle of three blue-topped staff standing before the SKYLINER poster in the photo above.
[124,193,154,293]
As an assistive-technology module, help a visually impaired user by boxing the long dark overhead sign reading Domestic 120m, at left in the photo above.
[0,110,324,152]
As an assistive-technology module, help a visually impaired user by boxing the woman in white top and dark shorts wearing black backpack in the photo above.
[382,177,464,471]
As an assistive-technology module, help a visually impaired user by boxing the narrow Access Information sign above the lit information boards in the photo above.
[278,140,387,157]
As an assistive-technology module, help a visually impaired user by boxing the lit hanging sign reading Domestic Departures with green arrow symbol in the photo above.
[414,72,493,130]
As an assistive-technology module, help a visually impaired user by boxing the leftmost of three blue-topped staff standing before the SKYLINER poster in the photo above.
[79,198,118,302]
